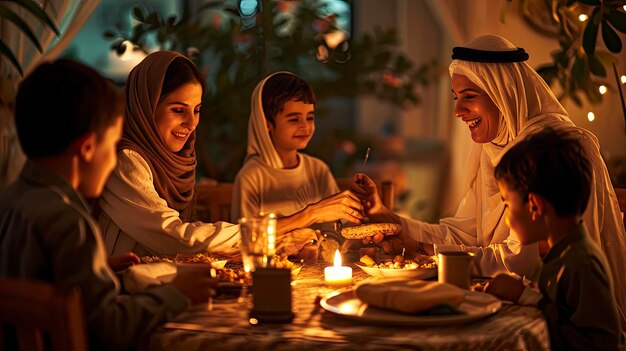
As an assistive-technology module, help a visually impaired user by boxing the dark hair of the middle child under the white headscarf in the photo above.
[261,73,317,125]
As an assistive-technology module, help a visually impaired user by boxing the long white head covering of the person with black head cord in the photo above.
[449,35,626,328]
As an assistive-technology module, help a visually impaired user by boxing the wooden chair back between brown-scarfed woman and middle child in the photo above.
[194,183,233,223]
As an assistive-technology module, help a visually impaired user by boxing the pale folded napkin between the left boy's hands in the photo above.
[122,262,176,294]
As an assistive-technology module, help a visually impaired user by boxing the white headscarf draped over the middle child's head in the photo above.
[246,71,293,169]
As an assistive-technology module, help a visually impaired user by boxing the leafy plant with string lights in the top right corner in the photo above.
[507,0,626,108]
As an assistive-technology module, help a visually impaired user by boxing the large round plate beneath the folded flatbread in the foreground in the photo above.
[320,289,502,326]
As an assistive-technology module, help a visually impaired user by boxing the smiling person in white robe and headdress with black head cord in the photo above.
[355,35,626,327]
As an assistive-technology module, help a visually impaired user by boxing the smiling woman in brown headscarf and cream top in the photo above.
[97,51,239,256]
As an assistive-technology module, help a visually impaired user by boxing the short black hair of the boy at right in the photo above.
[495,128,592,216]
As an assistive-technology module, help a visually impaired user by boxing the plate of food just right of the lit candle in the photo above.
[355,255,437,279]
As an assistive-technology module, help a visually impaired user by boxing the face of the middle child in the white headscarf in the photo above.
[269,100,315,153]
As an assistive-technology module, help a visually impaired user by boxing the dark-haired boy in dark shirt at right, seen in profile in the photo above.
[485,129,623,350]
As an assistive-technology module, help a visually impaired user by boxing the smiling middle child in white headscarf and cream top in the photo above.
[231,72,364,256]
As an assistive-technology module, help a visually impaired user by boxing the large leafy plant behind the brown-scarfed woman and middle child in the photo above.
[105,0,436,181]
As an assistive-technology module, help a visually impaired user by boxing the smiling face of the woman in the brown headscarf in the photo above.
[154,83,202,152]
